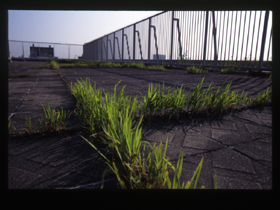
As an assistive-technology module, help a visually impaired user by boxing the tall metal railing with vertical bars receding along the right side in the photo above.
[83,11,272,71]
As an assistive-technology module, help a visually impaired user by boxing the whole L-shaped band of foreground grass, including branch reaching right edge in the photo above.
[71,78,271,189]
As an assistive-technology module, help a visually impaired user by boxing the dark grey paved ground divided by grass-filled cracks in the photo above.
[8,63,272,189]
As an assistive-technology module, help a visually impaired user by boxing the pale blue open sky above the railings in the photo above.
[8,10,162,44]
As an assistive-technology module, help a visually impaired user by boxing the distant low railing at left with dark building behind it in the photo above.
[9,40,83,59]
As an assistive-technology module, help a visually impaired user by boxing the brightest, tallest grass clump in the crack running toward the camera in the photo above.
[71,80,218,189]
